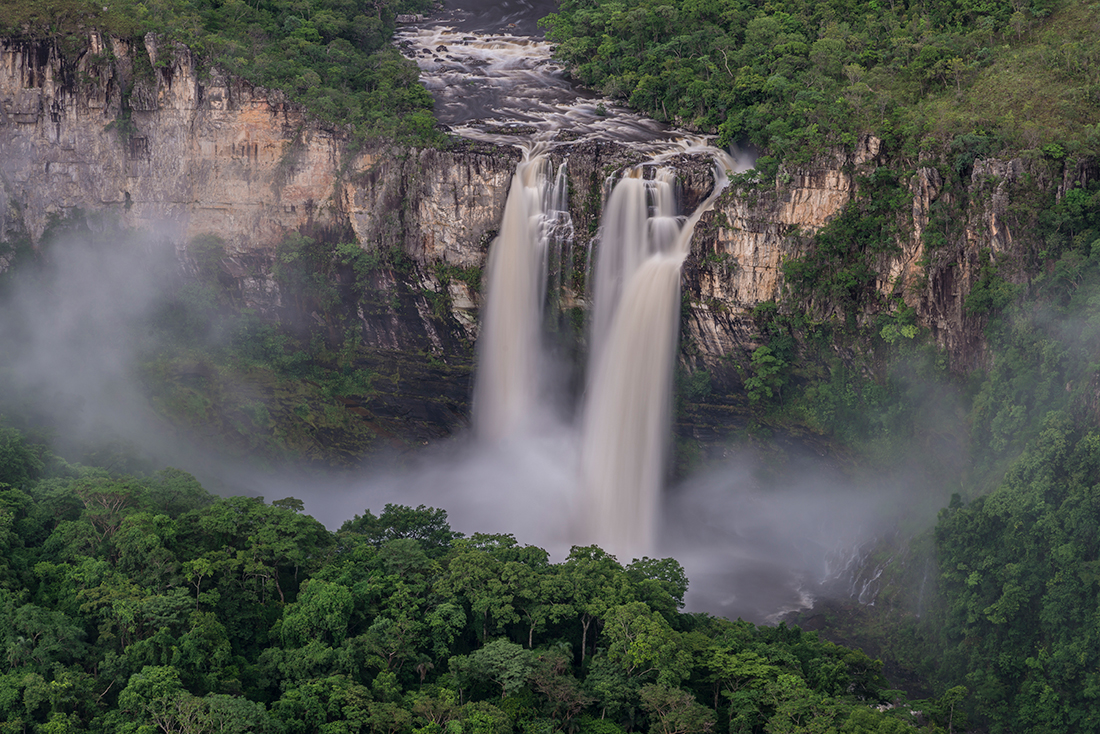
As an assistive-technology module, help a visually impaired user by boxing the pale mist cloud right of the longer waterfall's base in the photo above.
[659,450,903,622]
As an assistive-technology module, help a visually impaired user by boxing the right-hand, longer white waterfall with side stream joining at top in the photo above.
[578,152,733,560]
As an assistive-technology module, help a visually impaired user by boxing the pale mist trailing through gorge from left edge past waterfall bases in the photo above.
[0,222,963,621]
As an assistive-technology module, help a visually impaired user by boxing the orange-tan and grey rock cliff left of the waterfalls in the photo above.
[0,34,518,354]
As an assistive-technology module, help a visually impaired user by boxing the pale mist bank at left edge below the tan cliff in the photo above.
[0,227,221,477]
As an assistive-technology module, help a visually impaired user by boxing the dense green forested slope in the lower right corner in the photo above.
[936,413,1100,732]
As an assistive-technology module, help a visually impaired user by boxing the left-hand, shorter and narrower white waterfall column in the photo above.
[473,146,572,441]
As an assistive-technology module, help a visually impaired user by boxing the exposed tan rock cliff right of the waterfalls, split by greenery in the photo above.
[685,136,1100,380]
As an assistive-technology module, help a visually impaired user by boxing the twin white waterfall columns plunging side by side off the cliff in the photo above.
[474,140,733,560]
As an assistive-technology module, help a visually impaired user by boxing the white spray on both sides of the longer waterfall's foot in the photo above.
[297,426,903,623]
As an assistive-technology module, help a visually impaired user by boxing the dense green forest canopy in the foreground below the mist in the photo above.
[0,427,972,734]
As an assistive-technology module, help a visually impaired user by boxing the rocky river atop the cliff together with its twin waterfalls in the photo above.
[399,2,752,561]
